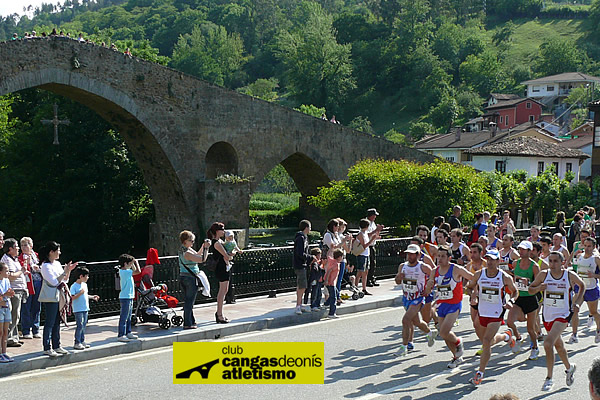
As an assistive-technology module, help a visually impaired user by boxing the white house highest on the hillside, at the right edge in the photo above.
[521,72,600,104]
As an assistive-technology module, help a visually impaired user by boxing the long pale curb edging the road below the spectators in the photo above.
[0,296,402,378]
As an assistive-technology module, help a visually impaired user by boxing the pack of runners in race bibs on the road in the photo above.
[396,225,600,391]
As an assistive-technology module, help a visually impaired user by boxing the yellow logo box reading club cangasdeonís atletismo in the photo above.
[173,342,325,385]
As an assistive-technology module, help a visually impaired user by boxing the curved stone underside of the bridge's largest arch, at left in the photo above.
[0,68,193,254]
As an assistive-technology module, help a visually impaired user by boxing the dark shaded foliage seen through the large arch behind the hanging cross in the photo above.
[0,89,154,261]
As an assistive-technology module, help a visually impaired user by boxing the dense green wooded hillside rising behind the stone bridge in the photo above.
[0,0,600,135]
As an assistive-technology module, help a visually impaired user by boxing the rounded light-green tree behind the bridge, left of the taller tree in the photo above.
[171,24,245,85]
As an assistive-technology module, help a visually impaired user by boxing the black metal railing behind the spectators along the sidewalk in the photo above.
[74,229,529,317]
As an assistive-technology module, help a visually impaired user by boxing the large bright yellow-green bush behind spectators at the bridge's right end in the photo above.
[309,160,496,232]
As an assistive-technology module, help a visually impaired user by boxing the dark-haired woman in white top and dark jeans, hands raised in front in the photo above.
[40,242,77,358]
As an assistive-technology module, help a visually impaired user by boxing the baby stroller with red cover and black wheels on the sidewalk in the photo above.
[131,283,183,329]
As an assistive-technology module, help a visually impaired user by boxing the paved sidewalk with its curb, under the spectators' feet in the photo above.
[0,279,402,377]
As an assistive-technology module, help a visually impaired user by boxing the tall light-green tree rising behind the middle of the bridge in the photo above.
[275,3,356,108]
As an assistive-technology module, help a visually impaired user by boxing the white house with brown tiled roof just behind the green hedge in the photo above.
[464,136,589,182]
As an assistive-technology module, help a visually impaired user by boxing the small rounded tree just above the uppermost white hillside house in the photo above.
[535,39,583,75]
